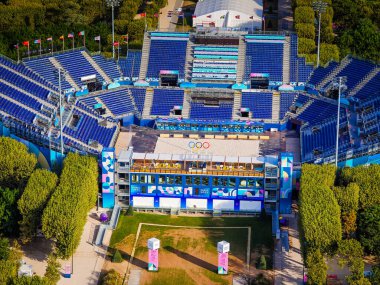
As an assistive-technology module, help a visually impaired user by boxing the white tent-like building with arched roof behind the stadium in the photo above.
[193,0,263,30]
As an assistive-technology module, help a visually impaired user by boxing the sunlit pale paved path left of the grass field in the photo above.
[58,206,110,285]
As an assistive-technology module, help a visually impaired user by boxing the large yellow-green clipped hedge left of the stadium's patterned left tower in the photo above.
[42,153,98,258]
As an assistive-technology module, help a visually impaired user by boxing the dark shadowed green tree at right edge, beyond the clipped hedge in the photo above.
[358,204,380,256]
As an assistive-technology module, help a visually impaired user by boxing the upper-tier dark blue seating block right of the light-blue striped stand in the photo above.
[245,35,285,82]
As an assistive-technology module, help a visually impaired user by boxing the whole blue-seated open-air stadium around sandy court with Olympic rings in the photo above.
[0,29,380,213]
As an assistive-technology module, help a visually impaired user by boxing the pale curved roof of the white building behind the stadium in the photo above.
[194,0,262,17]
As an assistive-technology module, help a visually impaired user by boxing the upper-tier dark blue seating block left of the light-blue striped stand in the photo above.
[146,32,189,81]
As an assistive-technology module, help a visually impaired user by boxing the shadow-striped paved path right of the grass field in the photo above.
[274,212,303,285]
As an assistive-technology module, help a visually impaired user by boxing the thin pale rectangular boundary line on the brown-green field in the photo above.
[123,223,252,284]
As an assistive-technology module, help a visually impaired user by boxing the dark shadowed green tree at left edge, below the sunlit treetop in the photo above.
[0,188,20,235]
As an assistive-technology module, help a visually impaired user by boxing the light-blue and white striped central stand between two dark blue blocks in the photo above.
[191,45,238,82]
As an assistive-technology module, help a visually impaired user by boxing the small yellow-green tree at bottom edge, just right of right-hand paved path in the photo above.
[306,249,327,285]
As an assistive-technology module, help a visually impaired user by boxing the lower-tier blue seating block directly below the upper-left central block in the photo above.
[150,89,184,116]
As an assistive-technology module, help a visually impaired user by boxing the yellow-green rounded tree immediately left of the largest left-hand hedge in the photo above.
[18,169,58,241]
